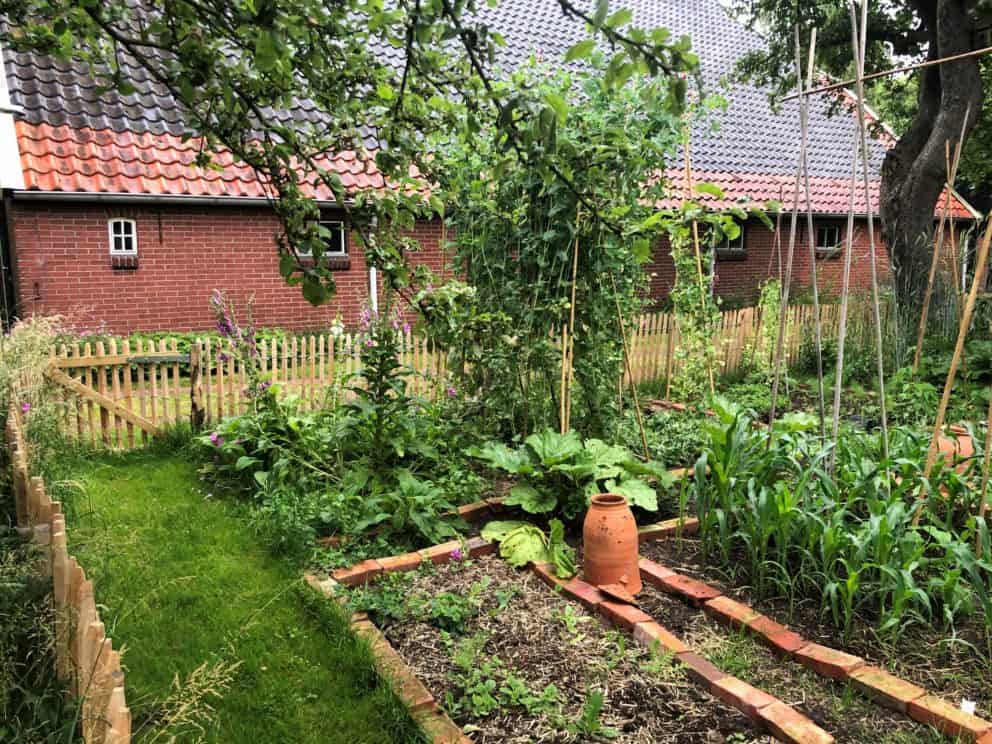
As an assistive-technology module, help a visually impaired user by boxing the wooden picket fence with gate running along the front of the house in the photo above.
[42,303,869,447]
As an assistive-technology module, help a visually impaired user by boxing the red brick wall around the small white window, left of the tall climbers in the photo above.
[11,202,450,333]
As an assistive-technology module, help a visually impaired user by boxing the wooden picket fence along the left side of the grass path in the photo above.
[6,403,131,744]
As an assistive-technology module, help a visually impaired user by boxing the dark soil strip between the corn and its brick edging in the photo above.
[640,538,992,724]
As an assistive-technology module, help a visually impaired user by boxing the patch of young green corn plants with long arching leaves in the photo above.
[686,399,992,638]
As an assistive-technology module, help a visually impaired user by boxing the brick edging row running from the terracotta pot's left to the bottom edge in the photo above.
[530,564,836,744]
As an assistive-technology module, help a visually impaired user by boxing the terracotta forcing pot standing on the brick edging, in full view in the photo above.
[582,493,641,594]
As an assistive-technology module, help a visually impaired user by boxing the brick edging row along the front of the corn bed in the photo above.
[639,558,992,744]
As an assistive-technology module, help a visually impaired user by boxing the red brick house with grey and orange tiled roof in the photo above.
[0,0,977,332]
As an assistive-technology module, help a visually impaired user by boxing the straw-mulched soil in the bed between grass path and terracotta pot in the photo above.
[360,556,773,744]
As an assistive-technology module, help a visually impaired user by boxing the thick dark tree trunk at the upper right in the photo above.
[879,0,982,308]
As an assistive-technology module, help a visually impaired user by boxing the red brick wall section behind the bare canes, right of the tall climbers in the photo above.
[647,217,889,300]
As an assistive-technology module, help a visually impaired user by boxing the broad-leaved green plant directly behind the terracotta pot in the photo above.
[470,429,672,519]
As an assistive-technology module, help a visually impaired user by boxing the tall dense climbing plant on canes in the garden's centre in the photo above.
[419,61,696,436]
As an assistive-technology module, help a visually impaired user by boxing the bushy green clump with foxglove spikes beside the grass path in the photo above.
[199,300,482,557]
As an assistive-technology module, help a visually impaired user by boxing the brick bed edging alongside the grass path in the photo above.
[304,576,472,744]
